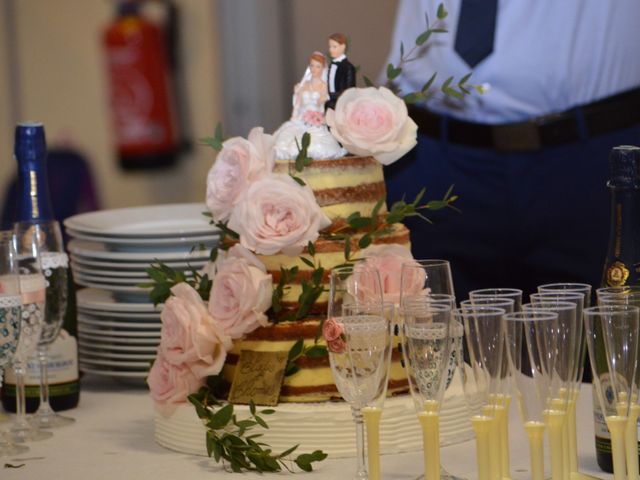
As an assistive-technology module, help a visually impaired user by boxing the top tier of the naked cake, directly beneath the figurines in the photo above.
[274,157,386,225]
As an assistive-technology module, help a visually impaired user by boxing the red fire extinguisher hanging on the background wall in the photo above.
[103,0,180,169]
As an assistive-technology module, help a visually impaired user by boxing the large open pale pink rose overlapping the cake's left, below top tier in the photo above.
[228,174,331,255]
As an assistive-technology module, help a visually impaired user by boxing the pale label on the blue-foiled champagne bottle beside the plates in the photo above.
[5,330,79,386]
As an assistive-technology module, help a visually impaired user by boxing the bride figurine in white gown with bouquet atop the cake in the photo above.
[273,52,347,160]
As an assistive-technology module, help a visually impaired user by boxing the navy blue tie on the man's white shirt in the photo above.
[454,0,498,67]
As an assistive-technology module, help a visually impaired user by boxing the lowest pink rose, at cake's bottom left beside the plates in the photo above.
[147,351,203,417]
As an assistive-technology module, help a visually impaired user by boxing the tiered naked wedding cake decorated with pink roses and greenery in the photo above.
[148,41,470,468]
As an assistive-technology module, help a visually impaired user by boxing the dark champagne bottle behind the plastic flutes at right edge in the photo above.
[593,145,640,472]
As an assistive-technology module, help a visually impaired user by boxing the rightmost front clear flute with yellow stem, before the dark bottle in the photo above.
[584,305,640,480]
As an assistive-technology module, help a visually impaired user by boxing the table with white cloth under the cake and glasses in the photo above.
[0,376,613,480]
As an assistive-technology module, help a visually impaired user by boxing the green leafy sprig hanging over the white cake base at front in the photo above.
[188,386,327,473]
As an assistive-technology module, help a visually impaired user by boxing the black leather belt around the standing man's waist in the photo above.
[409,88,640,152]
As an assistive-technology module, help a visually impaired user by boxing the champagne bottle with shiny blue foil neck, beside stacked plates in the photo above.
[2,123,80,412]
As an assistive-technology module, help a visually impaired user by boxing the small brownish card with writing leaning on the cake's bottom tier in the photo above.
[229,350,289,406]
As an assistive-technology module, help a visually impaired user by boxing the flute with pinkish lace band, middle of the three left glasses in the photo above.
[10,229,53,442]
